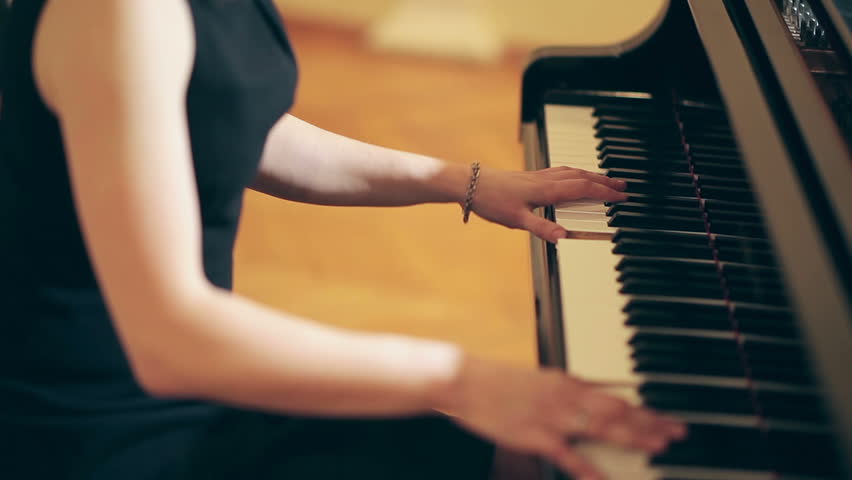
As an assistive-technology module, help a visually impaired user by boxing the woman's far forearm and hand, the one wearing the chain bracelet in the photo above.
[252,115,626,242]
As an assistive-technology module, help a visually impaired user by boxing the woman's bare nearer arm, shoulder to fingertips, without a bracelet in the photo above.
[35,0,683,478]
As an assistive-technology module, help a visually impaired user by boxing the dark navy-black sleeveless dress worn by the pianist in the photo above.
[0,0,491,480]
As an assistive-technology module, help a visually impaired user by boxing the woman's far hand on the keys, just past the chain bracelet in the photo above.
[473,167,627,243]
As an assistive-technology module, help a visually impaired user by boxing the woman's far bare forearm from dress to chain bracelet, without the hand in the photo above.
[252,114,470,207]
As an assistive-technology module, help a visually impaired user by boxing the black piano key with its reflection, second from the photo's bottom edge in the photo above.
[639,382,826,424]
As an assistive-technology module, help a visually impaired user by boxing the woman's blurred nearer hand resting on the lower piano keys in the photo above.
[436,358,686,480]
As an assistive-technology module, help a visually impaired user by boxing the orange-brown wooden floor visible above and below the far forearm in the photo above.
[236,18,535,365]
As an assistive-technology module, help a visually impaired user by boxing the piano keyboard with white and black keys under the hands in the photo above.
[545,98,839,480]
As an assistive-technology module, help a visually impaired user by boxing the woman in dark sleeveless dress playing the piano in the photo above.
[0,0,683,479]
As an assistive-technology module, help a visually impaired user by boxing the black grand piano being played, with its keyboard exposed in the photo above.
[521,0,852,480]
